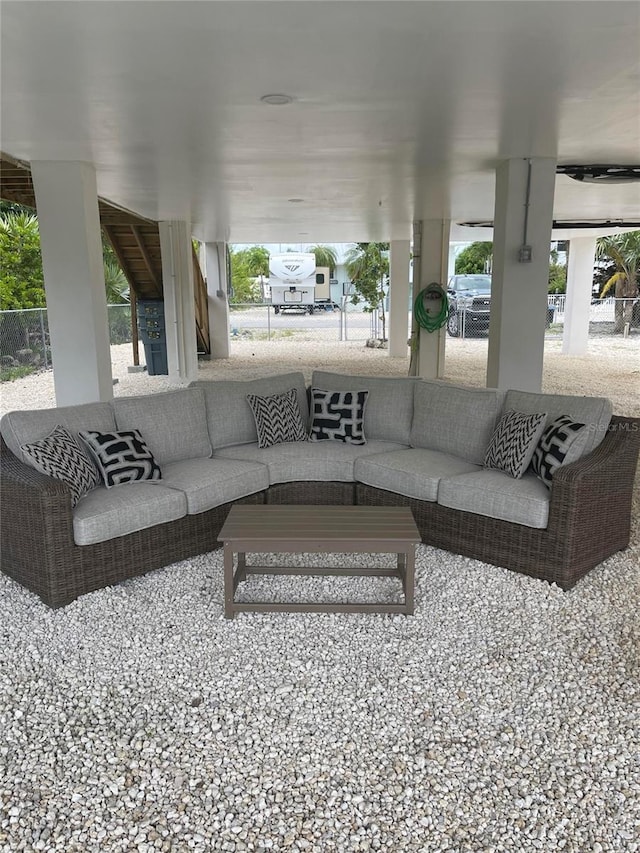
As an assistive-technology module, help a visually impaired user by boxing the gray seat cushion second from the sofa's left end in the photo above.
[162,458,269,515]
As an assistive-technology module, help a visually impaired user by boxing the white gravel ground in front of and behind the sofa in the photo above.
[0,330,640,853]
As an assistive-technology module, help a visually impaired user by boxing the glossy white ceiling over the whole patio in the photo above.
[0,0,640,243]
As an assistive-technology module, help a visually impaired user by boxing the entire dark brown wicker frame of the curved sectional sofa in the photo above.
[0,416,640,608]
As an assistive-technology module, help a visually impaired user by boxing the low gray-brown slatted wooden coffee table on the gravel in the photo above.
[218,504,421,619]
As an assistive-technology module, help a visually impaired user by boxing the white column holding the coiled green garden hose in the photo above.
[414,219,451,379]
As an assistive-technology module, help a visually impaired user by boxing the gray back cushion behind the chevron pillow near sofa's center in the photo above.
[192,372,309,450]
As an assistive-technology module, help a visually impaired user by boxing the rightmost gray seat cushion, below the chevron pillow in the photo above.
[438,469,550,528]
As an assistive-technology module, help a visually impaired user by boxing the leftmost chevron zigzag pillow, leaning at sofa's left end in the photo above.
[21,425,100,506]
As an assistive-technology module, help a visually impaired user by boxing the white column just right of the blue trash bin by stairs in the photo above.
[158,220,198,385]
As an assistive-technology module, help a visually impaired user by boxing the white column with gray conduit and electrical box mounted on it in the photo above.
[487,158,556,391]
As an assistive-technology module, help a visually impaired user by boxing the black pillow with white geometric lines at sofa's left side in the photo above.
[78,429,162,489]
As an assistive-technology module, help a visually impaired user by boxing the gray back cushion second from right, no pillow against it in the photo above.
[411,380,503,465]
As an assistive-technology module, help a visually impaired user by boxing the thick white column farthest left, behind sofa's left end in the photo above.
[31,160,113,406]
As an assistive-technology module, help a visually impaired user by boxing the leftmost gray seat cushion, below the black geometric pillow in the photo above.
[73,481,187,545]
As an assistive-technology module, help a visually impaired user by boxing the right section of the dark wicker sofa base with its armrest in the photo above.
[356,416,640,590]
